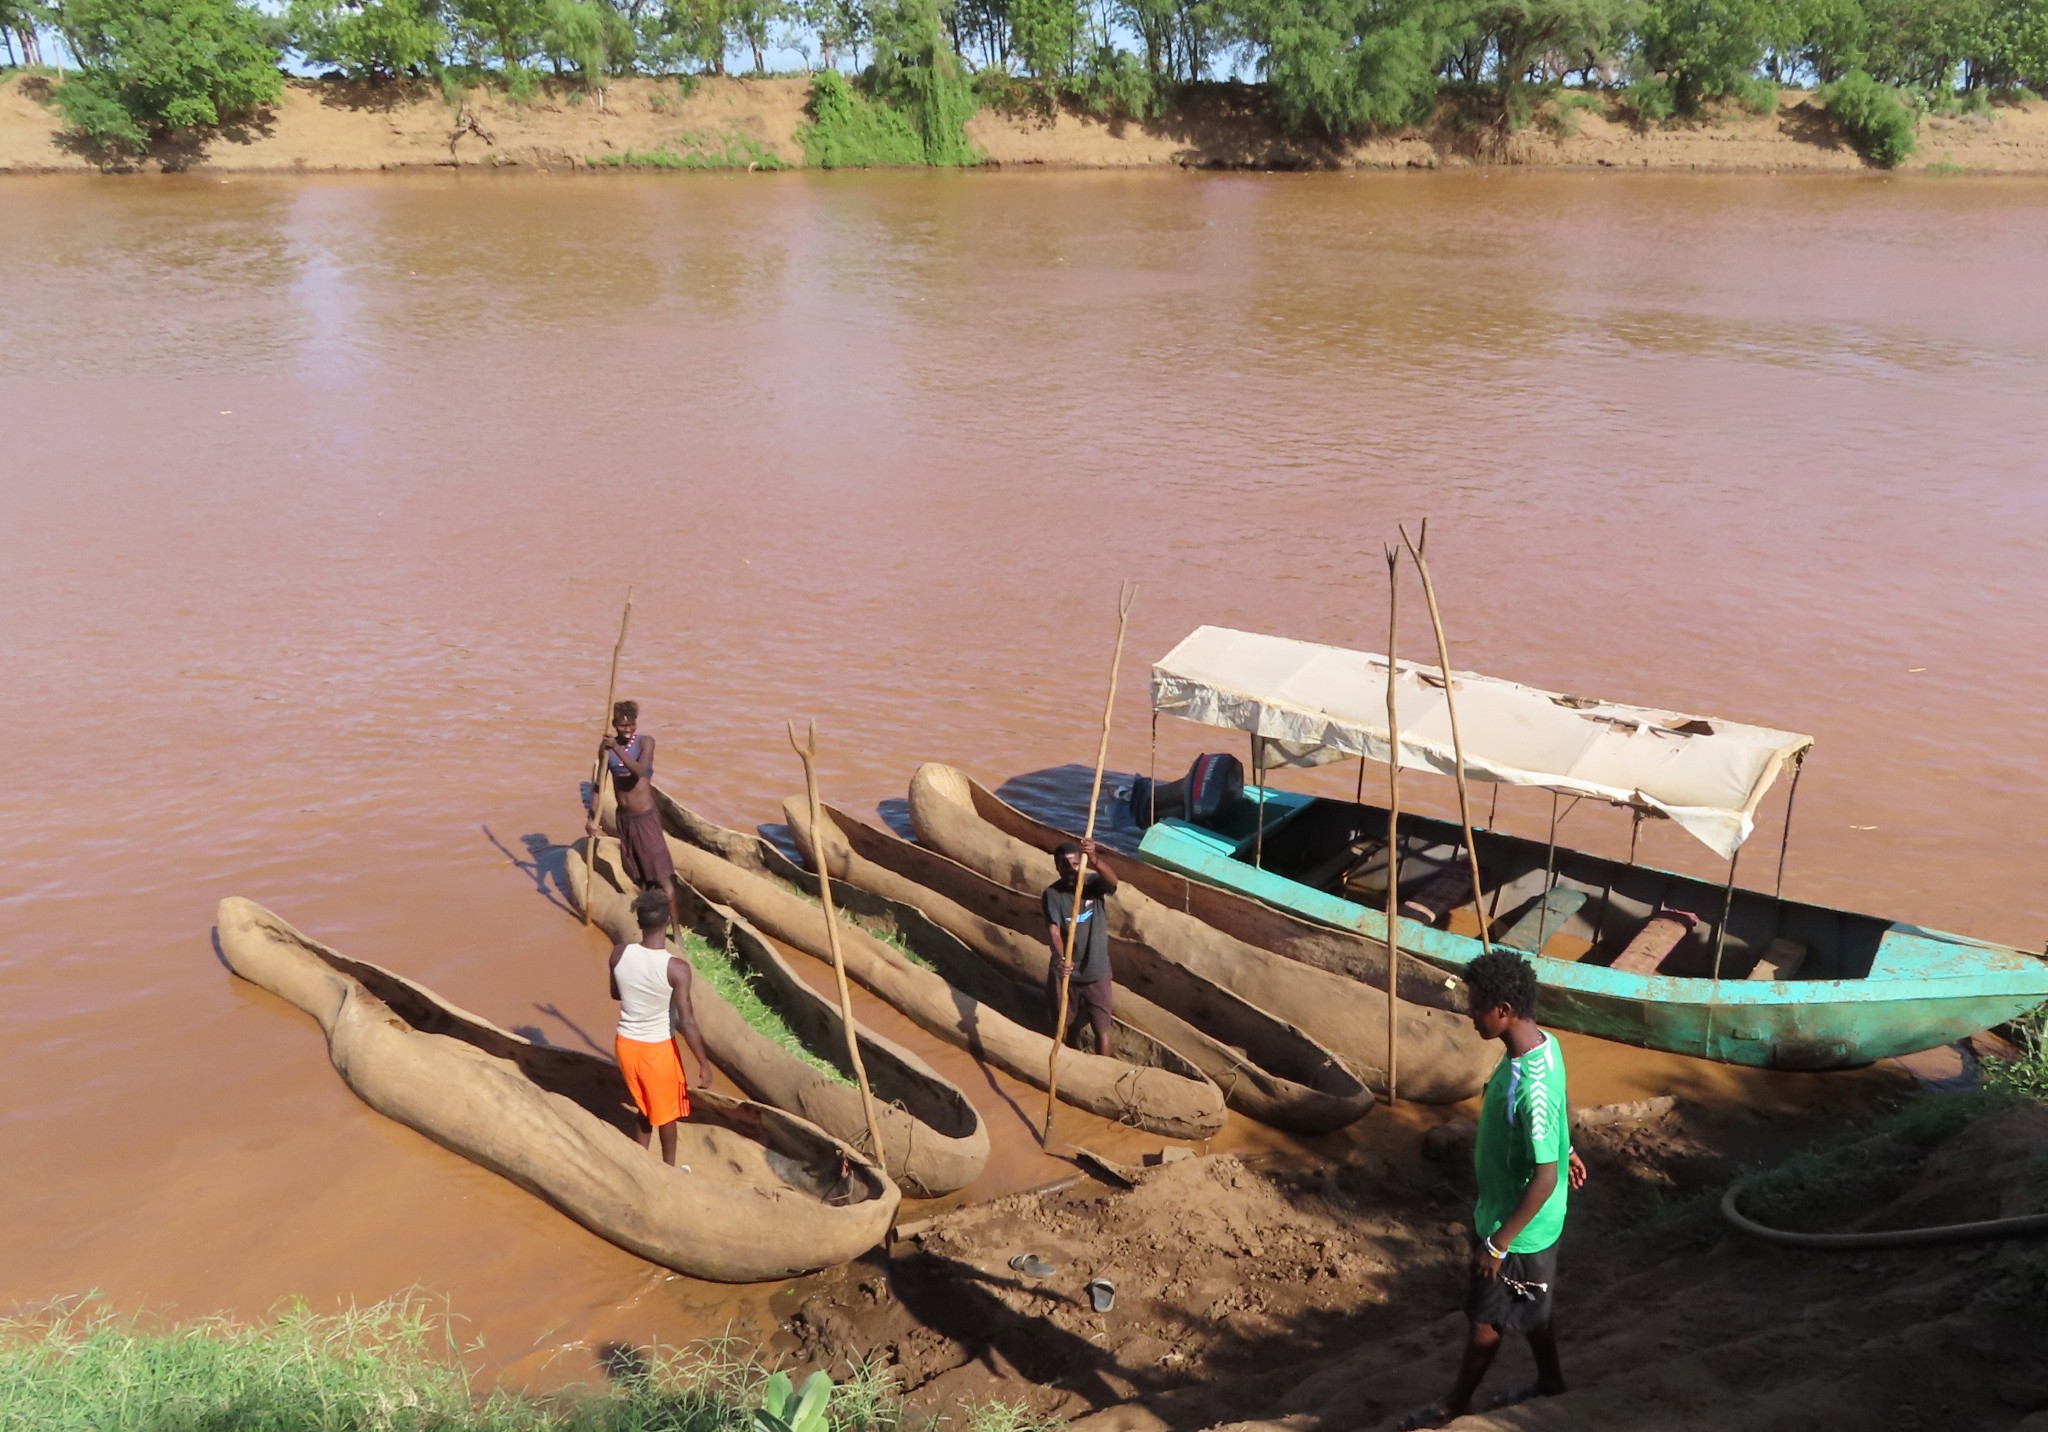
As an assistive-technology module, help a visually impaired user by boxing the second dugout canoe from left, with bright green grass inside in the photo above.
[567,842,989,1198]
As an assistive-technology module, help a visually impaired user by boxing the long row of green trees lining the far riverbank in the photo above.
[0,0,2048,160]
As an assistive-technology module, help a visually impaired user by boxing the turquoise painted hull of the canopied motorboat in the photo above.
[1141,791,2048,1069]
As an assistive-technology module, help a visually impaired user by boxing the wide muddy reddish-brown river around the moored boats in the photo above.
[0,174,2048,1381]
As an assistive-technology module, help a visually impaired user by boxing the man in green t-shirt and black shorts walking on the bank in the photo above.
[1401,951,1585,1428]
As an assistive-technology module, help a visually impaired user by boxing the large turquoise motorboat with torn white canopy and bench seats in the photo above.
[1128,627,2048,1069]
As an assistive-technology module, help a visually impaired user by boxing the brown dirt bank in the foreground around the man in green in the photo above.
[786,1104,2048,1432]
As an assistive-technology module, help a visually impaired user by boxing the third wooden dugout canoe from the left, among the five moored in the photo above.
[655,787,1225,1139]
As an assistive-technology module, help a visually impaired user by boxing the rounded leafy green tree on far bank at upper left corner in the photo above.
[55,0,285,154]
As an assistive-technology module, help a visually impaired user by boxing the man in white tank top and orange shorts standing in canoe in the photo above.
[612,889,711,1166]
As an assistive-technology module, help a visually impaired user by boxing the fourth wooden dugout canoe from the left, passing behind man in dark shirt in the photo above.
[782,797,1372,1133]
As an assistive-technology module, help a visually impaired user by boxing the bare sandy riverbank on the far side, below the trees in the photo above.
[0,76,2048,174]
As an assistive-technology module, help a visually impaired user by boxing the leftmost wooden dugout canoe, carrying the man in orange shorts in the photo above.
[215,897,901,1282]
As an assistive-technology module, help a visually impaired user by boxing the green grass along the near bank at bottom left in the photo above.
[0,1297,1055,1432]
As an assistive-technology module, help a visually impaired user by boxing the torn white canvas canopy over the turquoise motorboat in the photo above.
[1153,627,1812,858]
